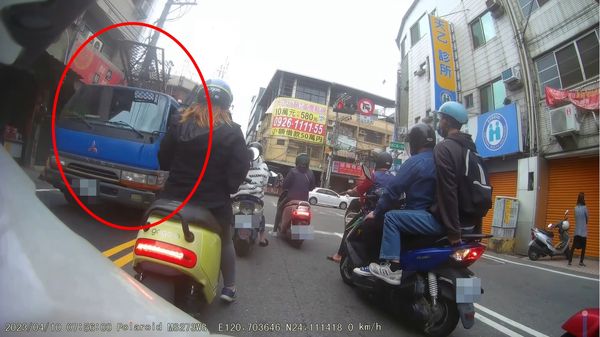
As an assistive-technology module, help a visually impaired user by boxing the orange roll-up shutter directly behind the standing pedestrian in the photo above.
[545,155,600,257]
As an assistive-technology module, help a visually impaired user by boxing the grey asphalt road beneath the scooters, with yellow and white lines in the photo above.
[38,186,599,336]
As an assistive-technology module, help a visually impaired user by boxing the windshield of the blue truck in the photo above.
[61,86,168,133]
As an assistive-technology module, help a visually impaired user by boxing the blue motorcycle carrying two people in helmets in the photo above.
[340,164,491,336]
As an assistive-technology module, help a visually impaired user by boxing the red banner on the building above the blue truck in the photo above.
[73,39,125,85]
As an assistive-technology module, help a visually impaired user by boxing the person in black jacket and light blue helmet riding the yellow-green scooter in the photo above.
[158,80,250,302]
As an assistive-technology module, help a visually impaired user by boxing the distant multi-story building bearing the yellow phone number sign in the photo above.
[246,70,394,191]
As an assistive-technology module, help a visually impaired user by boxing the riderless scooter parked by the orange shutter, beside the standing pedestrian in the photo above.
[527,210,570,261]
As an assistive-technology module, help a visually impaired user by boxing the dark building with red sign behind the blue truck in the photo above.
[0,0,155,165]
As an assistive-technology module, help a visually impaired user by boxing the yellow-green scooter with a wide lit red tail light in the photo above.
[133,200,221,311]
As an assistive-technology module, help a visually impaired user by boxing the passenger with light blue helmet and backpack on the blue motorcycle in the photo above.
[431,101,492,245]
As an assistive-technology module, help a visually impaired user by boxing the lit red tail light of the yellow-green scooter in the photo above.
[134,239,198,268]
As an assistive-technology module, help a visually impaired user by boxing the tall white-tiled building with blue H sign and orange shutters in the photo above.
[396,0,599,256]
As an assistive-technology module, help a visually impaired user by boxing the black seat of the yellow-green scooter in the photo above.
[144,199,221,234]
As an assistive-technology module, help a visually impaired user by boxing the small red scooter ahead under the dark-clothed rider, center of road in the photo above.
[273,192,314,248]
